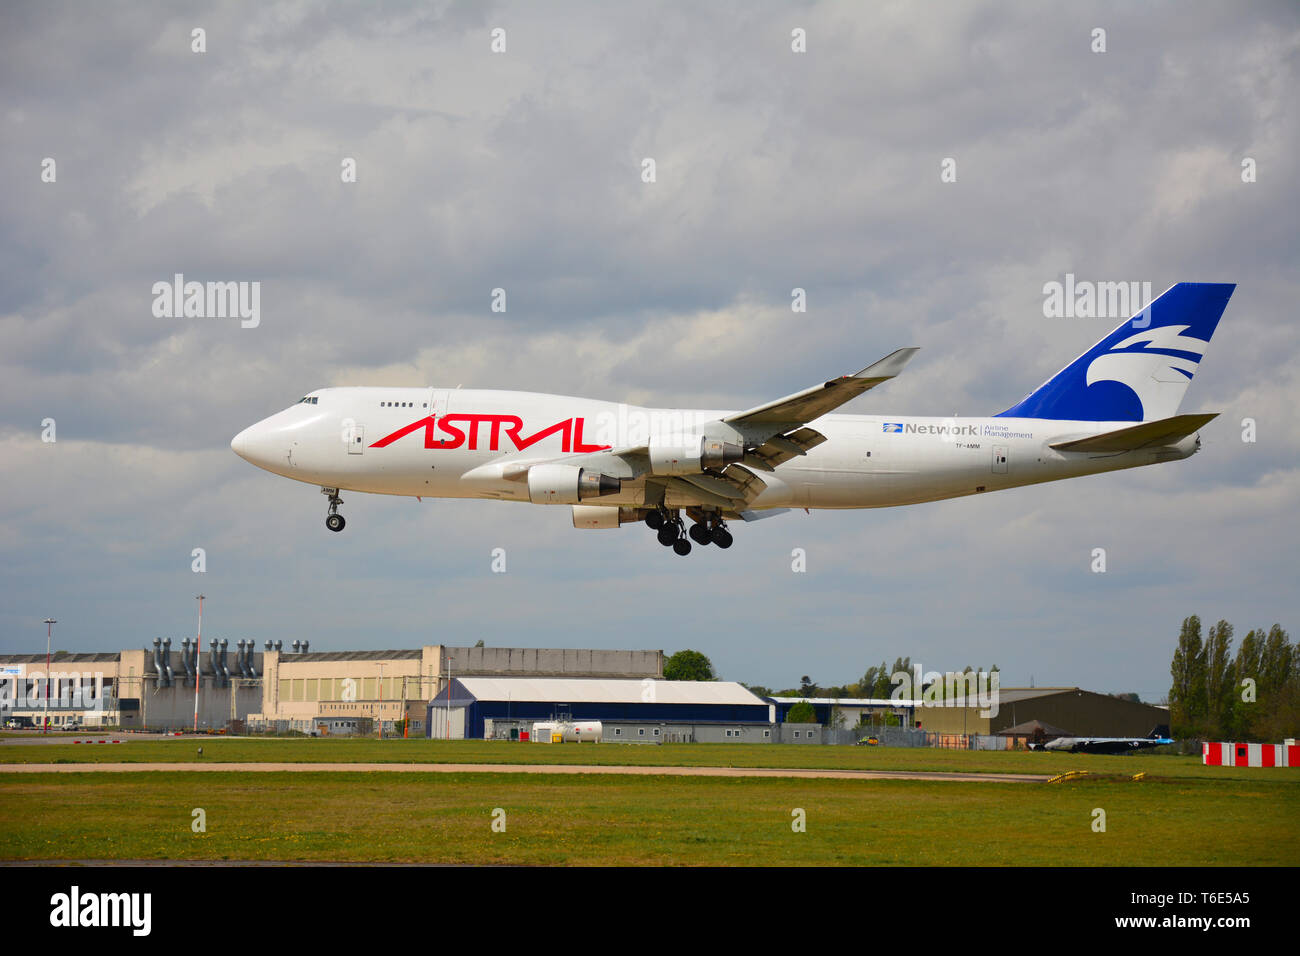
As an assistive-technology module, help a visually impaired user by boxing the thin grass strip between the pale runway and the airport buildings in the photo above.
[0,737,1300,786]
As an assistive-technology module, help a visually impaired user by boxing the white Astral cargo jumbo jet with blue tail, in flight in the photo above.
[230,282,1236,555]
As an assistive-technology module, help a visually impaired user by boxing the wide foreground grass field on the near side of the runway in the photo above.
[0,770,1300,866]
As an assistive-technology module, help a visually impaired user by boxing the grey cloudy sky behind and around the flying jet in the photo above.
[0,0,1300,700]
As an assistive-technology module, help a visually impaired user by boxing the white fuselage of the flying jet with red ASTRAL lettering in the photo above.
[231,388,1199,510]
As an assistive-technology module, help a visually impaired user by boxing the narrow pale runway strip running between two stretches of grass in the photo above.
[0,761,1050,783]
